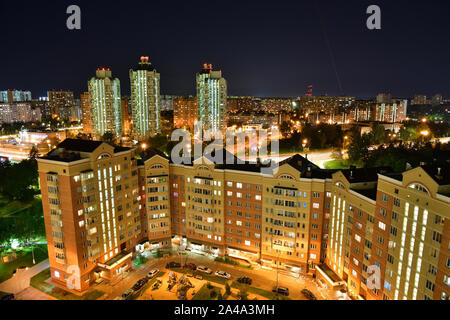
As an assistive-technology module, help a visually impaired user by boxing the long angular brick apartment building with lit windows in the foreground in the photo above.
[38,139,450,299]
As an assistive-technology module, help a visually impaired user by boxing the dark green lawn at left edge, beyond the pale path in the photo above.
[0,244,48,282]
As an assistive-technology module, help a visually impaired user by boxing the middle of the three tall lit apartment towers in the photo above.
[130,57,161,140]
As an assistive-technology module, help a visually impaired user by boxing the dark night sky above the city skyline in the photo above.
[0,0,450,97]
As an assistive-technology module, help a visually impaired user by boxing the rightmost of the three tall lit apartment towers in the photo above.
[197,64,227,131]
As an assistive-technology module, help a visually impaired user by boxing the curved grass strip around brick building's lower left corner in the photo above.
[30,268,104,300]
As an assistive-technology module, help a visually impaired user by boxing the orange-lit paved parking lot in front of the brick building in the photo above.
[108,253,332,300]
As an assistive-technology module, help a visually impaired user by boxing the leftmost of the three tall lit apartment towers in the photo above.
[88,68,122,137]
